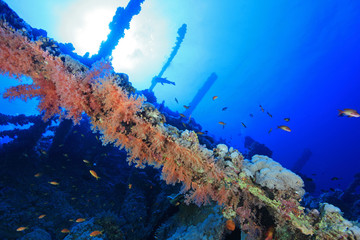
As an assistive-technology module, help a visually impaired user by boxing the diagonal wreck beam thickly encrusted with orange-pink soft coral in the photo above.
[0,22,355,239]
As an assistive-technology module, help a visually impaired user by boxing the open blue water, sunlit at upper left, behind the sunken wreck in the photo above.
[0,0,360,238]
